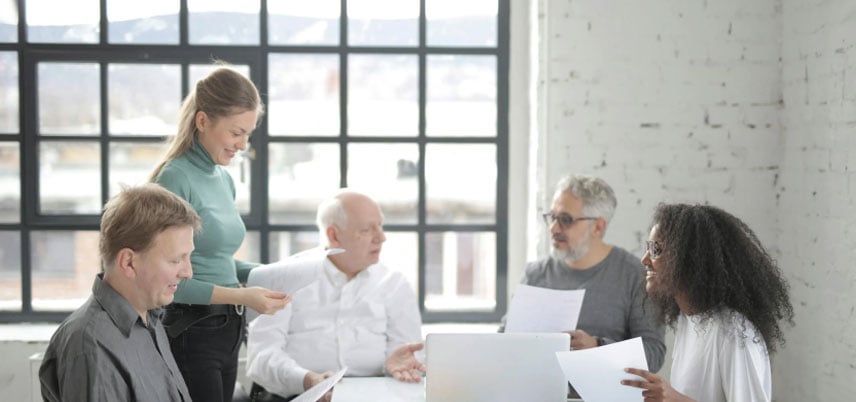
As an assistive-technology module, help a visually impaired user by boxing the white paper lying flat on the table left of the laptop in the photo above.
[333,377,425,402]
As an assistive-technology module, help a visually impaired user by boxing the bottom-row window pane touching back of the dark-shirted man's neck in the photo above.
[30,231,101,311]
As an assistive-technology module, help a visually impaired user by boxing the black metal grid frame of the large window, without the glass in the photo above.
[0,0,510,323]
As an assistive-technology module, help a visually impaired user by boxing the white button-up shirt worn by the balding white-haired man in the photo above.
[247,250,422,397]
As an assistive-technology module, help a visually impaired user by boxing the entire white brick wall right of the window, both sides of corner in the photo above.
[532,0,856,401]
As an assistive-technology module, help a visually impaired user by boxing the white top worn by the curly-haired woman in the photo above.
[671,312,772,402]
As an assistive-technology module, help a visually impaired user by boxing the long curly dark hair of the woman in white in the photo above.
[650,204,794,354]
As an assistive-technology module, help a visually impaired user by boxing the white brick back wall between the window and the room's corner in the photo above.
[539,0,781,252]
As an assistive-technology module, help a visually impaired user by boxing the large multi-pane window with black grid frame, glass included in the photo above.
[0,0,509,322]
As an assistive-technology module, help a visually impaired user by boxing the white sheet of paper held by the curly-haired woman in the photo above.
[556,337,648,402]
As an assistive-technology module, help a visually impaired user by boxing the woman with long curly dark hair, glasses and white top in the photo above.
[622,204,794,401]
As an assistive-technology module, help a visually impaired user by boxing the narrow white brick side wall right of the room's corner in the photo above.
[773,0,856,401]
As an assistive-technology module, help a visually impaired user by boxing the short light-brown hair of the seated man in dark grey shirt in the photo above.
[99,183,202,270]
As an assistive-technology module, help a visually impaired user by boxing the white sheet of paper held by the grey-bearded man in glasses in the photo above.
[505,284,586,332]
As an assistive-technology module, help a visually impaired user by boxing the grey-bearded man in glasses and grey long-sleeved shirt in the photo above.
[500,175,666,372]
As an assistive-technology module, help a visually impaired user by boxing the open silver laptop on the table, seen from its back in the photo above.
[425,333,571,402]
